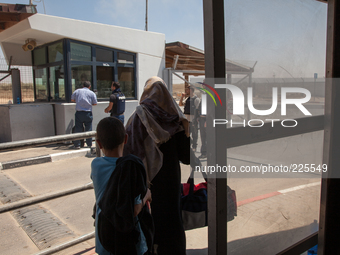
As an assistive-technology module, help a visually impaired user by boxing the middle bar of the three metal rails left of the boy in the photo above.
[0,182,93,214]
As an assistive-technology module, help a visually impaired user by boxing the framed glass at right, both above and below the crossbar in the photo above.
[220,0,327,255]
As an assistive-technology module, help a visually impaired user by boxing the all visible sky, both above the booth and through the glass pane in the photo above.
[0,0,327,78]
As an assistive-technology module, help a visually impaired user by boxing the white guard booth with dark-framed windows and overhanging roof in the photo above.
[0,14,165,142]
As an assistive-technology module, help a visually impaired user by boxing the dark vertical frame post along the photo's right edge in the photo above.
[318,0,340,255]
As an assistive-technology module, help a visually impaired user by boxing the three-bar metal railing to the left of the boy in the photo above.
[0,131,101,255]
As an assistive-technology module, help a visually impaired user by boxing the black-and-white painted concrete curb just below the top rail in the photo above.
[0,148,91,170]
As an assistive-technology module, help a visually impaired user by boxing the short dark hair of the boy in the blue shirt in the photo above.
[97,117,125,150]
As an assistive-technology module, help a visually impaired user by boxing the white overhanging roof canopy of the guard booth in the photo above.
[0,14,165,66]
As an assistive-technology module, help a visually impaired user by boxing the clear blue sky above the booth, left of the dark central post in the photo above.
[3,0,204,50]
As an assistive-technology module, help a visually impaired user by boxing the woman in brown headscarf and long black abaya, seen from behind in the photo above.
[124,77,190,255]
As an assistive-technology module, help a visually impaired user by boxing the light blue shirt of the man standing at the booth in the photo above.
[71,87,97,112]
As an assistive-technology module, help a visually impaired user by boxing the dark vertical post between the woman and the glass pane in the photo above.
[203,0,227,255]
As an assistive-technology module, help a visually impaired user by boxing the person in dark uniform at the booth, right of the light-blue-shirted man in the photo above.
[104,81,125,124]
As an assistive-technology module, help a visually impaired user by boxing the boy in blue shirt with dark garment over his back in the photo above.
[91,117,152,255]
